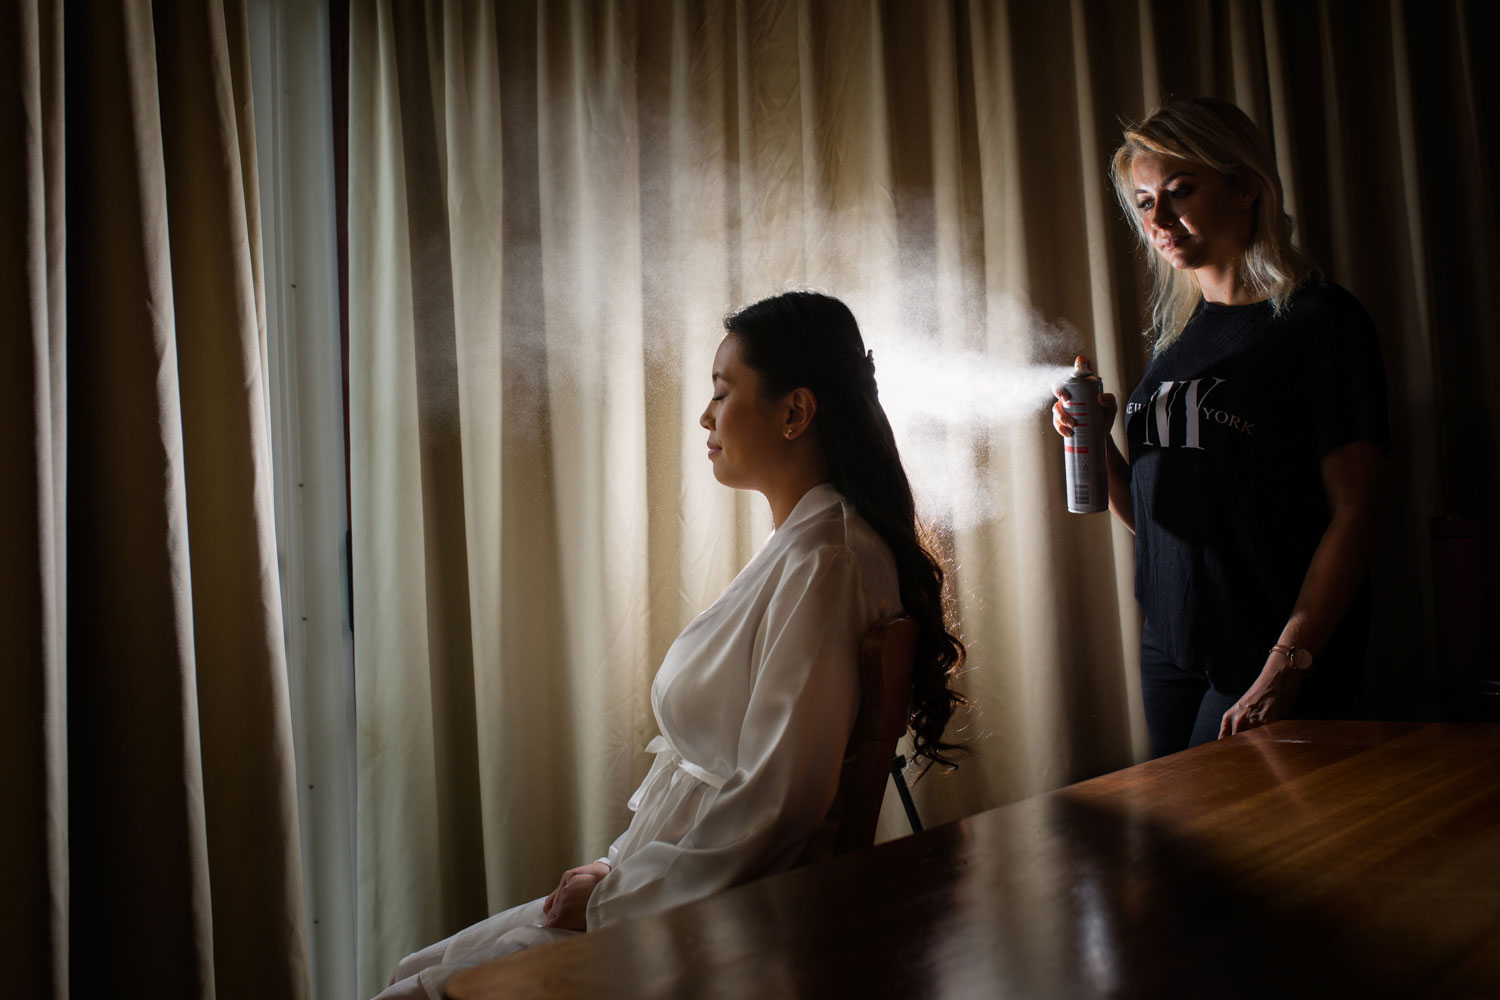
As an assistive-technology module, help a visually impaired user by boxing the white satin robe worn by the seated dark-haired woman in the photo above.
[390,484,900,997]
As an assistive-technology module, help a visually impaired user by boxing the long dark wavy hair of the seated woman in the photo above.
[725,291,966,769]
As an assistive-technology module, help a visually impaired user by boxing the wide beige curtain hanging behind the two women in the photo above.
[350,0,1500,993]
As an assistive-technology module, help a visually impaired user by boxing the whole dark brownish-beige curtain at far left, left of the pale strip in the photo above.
[0,0,308,997]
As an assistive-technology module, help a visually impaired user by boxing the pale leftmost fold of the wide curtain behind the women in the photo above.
[348,4,453,971]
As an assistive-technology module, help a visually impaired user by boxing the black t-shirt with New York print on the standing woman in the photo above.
[1125,283,1391,693]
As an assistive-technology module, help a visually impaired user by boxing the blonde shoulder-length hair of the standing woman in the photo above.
[1110,97,1319,354]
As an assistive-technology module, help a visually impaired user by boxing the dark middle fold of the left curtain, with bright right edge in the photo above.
[66,4,213,996]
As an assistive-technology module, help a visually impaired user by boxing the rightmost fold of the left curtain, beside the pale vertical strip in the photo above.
[153,0,306,996]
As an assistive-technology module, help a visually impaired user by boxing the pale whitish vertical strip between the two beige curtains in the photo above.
[248,0,359,1000]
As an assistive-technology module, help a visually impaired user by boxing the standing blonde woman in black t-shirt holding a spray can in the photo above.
[1053,97,1389,756]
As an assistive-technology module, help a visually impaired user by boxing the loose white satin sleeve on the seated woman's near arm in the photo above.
[588,546,875,928]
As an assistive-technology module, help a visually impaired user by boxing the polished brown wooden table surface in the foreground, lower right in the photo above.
[449,723,1500,1000]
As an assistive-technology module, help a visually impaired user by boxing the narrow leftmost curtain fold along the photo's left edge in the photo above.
[0,3,69,997]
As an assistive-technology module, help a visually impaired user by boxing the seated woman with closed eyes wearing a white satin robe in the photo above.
[372,292,963,1000]
